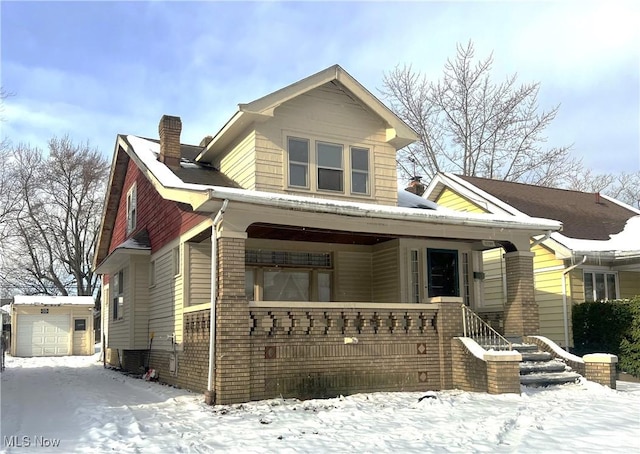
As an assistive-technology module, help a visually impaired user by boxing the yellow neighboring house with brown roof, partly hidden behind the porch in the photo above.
[423,173,640,348]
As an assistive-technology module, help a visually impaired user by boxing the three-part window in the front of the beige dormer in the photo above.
[287,137,371,195]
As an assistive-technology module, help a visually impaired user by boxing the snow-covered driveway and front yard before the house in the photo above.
[0,356,640,453]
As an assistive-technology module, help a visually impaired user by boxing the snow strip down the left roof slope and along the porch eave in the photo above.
[126,135,561,234]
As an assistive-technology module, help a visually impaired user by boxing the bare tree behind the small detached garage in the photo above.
[4,136,109,295]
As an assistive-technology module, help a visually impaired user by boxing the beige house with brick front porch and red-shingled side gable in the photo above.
[94,65,561,403]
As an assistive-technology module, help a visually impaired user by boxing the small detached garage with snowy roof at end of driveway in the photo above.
[11,296,94,356]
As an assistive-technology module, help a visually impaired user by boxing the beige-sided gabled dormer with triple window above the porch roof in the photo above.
[197,65,417,205]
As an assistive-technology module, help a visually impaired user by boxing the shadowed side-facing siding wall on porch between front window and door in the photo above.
[372,240,401,303]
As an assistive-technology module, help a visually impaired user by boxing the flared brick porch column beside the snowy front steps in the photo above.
[504,251,540,337]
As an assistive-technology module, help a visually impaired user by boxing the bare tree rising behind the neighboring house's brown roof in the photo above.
[381,42,579,186]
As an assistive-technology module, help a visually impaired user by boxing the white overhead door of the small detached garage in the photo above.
[16,314,71,356]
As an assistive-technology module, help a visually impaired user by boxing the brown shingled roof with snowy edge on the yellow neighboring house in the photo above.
[426,173,640,240]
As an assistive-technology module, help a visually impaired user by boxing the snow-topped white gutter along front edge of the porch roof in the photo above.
[201,186,562,231]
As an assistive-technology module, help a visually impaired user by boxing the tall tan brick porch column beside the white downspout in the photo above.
[215,232,251,404]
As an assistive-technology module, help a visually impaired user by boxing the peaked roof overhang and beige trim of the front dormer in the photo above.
[197,65,418,162]
